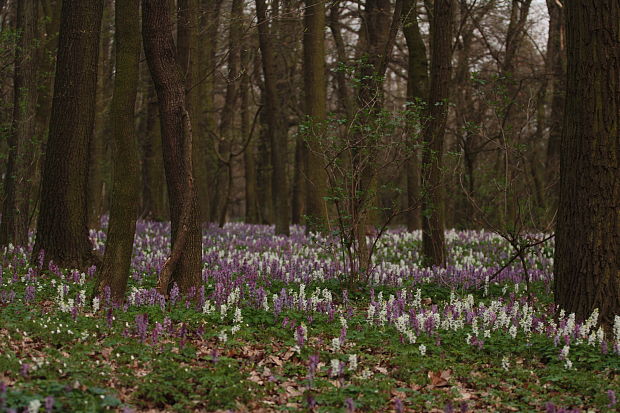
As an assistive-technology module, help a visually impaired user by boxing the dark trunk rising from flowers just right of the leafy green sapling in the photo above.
[422,0,453,266]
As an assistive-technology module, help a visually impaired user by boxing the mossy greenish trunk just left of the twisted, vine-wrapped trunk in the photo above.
[98,0,140,301]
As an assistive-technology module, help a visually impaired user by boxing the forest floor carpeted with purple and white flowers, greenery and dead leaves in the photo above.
[0,222,620,412]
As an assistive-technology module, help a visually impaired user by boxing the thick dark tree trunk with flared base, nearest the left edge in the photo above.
[34,0,102,268]
